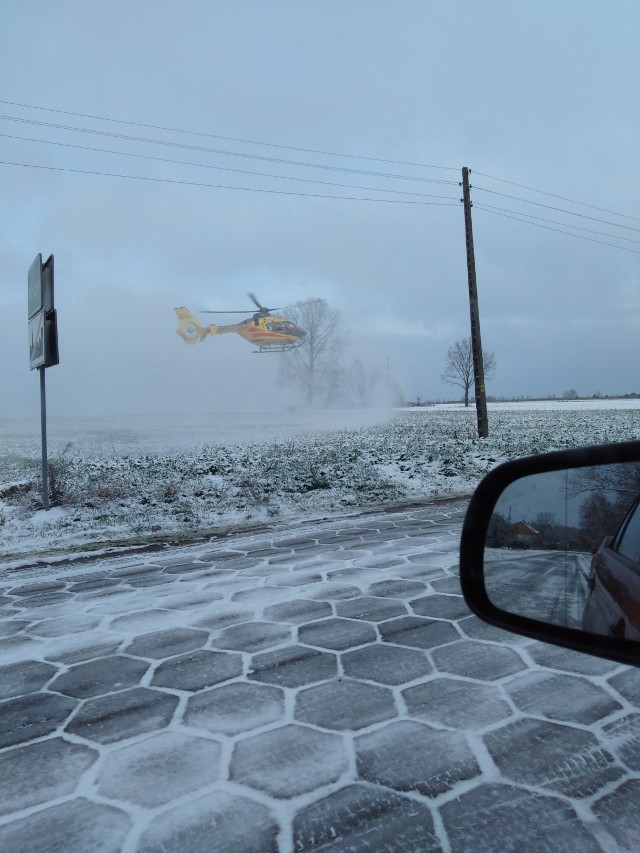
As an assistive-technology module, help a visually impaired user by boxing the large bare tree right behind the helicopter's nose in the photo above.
[281,299,345,406]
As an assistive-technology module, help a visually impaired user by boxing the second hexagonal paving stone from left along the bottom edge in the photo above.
[136,791,279,853]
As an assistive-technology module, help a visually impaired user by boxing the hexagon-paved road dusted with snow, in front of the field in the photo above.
[0,502,640,853]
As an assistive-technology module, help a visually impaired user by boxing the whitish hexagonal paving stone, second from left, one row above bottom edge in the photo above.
[96,732,221,808]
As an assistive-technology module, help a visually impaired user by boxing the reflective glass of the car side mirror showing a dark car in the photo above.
[484,462,640,640]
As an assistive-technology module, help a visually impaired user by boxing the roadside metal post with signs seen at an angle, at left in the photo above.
[27,254,59,510]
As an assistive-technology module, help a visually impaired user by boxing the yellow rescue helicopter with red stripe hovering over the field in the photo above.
[173,293,306,352]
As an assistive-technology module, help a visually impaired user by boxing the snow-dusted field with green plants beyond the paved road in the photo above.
[0,400,640,566]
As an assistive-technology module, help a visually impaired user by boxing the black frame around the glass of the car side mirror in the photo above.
[460,441,640,666]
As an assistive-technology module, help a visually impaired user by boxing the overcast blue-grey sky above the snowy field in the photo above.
[0,0,640,417]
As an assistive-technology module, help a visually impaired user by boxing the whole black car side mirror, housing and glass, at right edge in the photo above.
[460,441,640,666]
